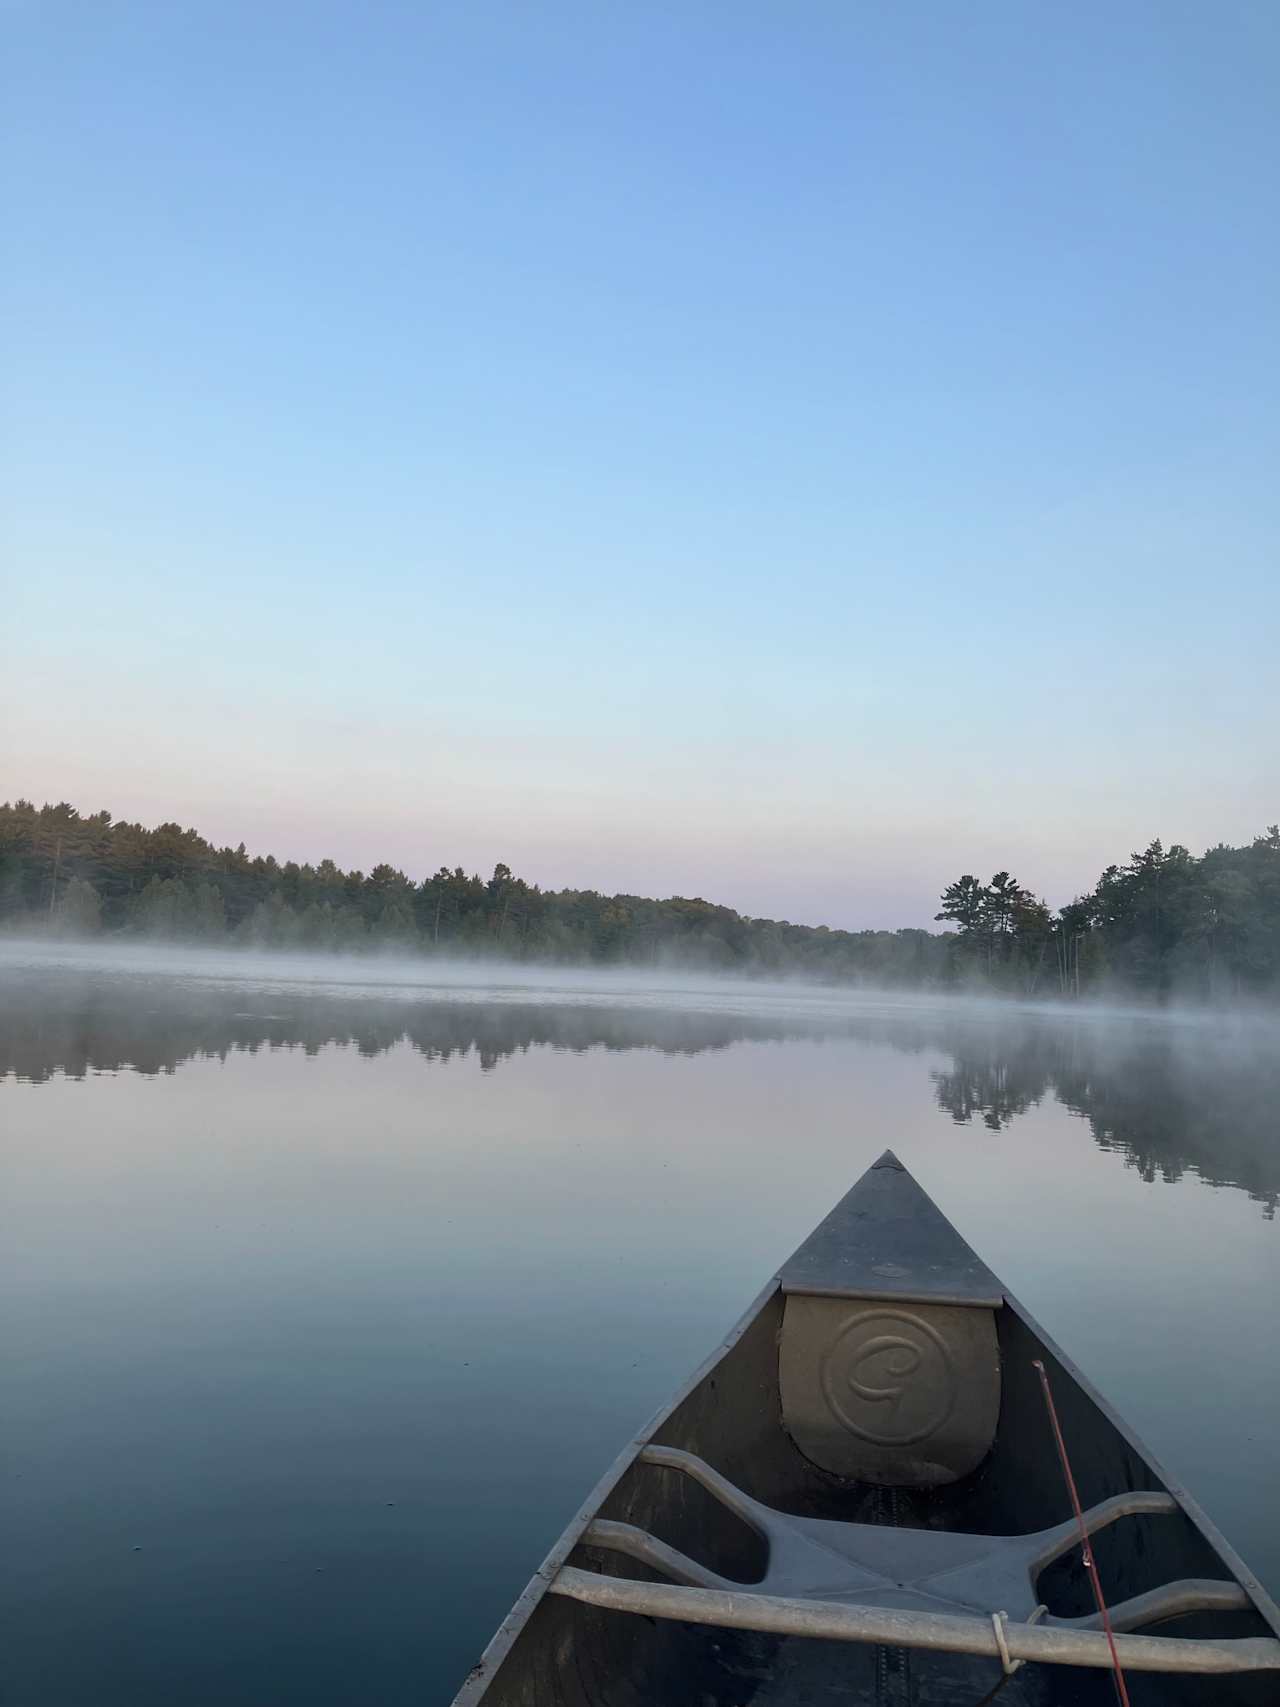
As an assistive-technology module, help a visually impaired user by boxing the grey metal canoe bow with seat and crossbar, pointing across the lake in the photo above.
[454,1151,1280,1707]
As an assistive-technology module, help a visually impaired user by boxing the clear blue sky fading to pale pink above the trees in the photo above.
[0,0,1280,927]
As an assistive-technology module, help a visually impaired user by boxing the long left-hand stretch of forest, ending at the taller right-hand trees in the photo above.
[0,801,945,985]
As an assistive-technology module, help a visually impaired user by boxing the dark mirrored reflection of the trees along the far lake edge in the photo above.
[0,968,1280,1217]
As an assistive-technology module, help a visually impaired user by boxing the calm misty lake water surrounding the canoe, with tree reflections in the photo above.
[0,946,1280,1707]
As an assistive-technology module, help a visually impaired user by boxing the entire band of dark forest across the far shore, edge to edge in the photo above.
[0,801,1280,1000]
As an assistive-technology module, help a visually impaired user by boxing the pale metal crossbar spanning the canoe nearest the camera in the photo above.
[550,1565,1280,1676]
